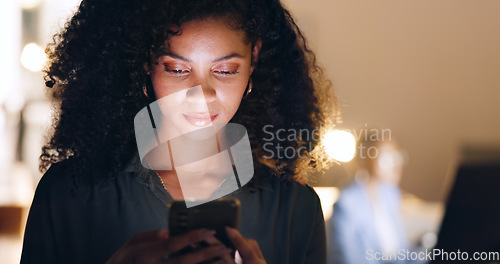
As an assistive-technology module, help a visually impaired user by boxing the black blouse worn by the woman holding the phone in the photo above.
[21,159,326,264]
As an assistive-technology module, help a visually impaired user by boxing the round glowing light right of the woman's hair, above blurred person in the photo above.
[323,130,356,162]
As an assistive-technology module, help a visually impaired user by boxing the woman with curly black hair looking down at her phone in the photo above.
[21,0,338,263]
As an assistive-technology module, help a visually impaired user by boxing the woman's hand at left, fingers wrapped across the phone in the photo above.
[106,229,231,264]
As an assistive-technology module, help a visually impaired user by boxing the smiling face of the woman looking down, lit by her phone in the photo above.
[149,19,260,138]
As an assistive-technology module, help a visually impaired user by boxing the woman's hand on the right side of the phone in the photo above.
[226,227,266,264]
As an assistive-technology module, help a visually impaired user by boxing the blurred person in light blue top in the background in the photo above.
[328,133,409,264]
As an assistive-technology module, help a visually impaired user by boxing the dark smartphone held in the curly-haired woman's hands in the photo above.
[168,198,240,257]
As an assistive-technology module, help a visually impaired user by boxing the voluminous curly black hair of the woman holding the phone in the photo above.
[40,0,338,188]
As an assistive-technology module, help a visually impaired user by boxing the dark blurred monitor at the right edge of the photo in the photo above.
[431,148,500,263]
